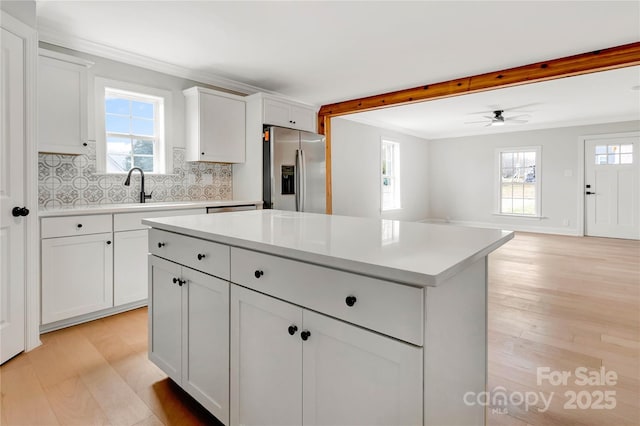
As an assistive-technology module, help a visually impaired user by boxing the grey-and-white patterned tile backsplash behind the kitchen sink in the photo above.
[38,142,233,208]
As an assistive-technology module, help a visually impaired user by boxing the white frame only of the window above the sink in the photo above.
[94,77,173,175]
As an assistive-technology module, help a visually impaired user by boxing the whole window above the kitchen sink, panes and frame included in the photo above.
[96,78,172,174]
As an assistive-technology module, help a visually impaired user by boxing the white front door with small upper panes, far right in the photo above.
[584,135,640,240]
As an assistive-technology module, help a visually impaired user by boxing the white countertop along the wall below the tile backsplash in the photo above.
[38,200,262,217]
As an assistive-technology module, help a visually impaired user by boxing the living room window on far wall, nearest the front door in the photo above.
[498,146,542,217]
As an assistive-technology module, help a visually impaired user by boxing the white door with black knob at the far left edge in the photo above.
[0,28,26,363]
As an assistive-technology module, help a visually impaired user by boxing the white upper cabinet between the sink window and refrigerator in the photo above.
[183,87,245,163]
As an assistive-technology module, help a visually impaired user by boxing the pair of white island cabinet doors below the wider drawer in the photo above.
[231,285,423,425]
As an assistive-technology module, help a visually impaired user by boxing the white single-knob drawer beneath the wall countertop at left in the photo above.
[40,214,112,238]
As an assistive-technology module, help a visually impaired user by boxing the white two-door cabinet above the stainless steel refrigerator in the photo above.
[262,97,317,133]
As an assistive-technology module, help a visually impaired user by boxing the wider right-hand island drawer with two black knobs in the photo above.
[231,247,424,346]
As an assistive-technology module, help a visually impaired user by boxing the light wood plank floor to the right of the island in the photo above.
[487,233,640,426]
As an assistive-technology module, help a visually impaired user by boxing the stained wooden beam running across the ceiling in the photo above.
[318,42,640,134]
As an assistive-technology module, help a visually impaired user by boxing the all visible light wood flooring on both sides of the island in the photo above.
[0,234,640,426]
